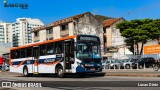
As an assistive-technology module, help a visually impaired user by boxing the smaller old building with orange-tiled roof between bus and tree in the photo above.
[103,18,132,59]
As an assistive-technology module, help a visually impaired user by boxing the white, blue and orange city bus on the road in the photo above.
[10,35,102,78]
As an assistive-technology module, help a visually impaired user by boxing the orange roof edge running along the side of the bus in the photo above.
[10,35,76,50]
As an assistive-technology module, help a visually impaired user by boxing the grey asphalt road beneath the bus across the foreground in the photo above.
[0,72,160,90]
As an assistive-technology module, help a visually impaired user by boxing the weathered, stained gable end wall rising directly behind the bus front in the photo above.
[74,13,103,54]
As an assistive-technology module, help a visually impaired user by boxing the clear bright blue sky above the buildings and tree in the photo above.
[0,0,160,24]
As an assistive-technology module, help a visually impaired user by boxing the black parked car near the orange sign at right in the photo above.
[132,57,156,69]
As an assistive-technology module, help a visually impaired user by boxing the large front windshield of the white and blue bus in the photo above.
[76,42,100,58]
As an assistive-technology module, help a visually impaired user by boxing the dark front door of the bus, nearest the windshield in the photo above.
[64,40,74,72]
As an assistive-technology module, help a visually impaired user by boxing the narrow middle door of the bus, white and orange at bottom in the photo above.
[33,47,39,74]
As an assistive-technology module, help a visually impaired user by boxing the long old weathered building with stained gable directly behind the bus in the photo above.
[32,12,103,53]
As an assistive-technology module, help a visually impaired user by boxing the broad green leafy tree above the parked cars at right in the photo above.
[117,19,160,54]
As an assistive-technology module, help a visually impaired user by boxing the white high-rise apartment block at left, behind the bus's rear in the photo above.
[10,18,44,46]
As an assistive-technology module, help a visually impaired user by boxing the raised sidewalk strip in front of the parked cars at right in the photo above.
[103,68,160,77]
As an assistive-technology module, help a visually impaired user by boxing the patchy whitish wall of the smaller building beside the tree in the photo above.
[104,19,133,59]
